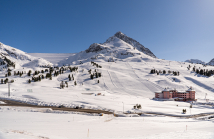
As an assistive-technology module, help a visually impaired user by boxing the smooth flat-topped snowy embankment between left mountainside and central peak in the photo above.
[27,53,74,64]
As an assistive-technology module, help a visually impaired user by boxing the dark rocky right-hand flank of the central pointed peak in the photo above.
[114,31,156,58]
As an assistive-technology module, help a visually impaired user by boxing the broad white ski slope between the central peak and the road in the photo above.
[0,60,214,115]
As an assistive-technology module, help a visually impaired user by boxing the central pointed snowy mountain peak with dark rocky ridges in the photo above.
[58,32,156,66]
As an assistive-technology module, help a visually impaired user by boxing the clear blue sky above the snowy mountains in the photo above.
[0,0,214,62]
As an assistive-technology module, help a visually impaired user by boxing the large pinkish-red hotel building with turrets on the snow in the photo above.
[155,87,195,101]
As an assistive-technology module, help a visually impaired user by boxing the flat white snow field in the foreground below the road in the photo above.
[0,107,214,139]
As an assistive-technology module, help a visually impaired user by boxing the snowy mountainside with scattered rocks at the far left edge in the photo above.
[0,43,52,70]
